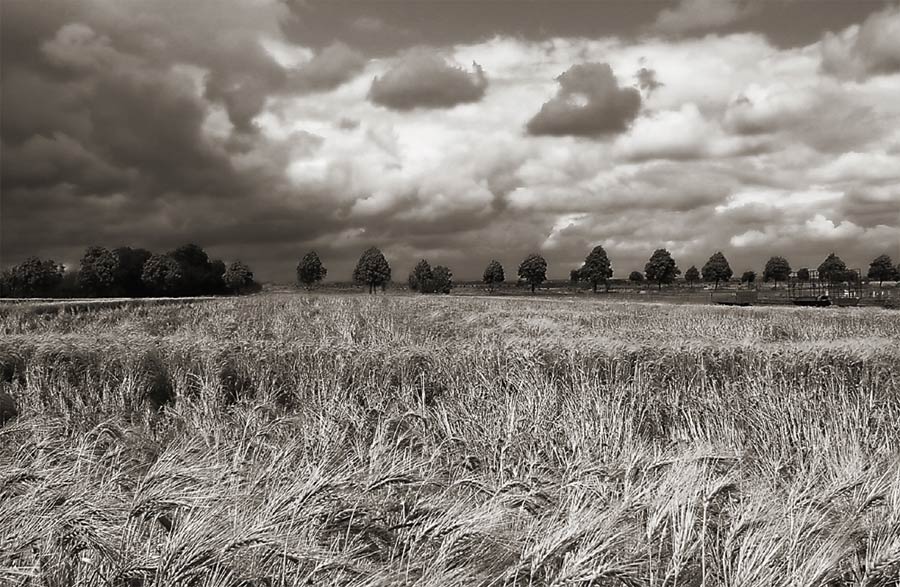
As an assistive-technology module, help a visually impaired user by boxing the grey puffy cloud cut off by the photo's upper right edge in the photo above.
[821,5,900,79]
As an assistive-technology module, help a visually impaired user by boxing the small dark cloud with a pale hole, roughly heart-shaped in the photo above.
[526,63,641,137]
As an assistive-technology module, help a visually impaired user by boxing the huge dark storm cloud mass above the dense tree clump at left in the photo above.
[0,0,348,275]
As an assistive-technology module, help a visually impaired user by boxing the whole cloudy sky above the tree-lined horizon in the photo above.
[0,0,900,282]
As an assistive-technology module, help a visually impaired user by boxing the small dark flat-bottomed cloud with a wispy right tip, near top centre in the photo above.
[368,50,488,110]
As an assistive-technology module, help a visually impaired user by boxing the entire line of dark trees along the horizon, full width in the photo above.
[0,244,900,297]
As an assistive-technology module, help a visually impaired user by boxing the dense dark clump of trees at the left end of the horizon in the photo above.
[0,244,259,297]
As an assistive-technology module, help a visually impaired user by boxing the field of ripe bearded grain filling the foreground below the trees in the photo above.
[0,295,900,587]
